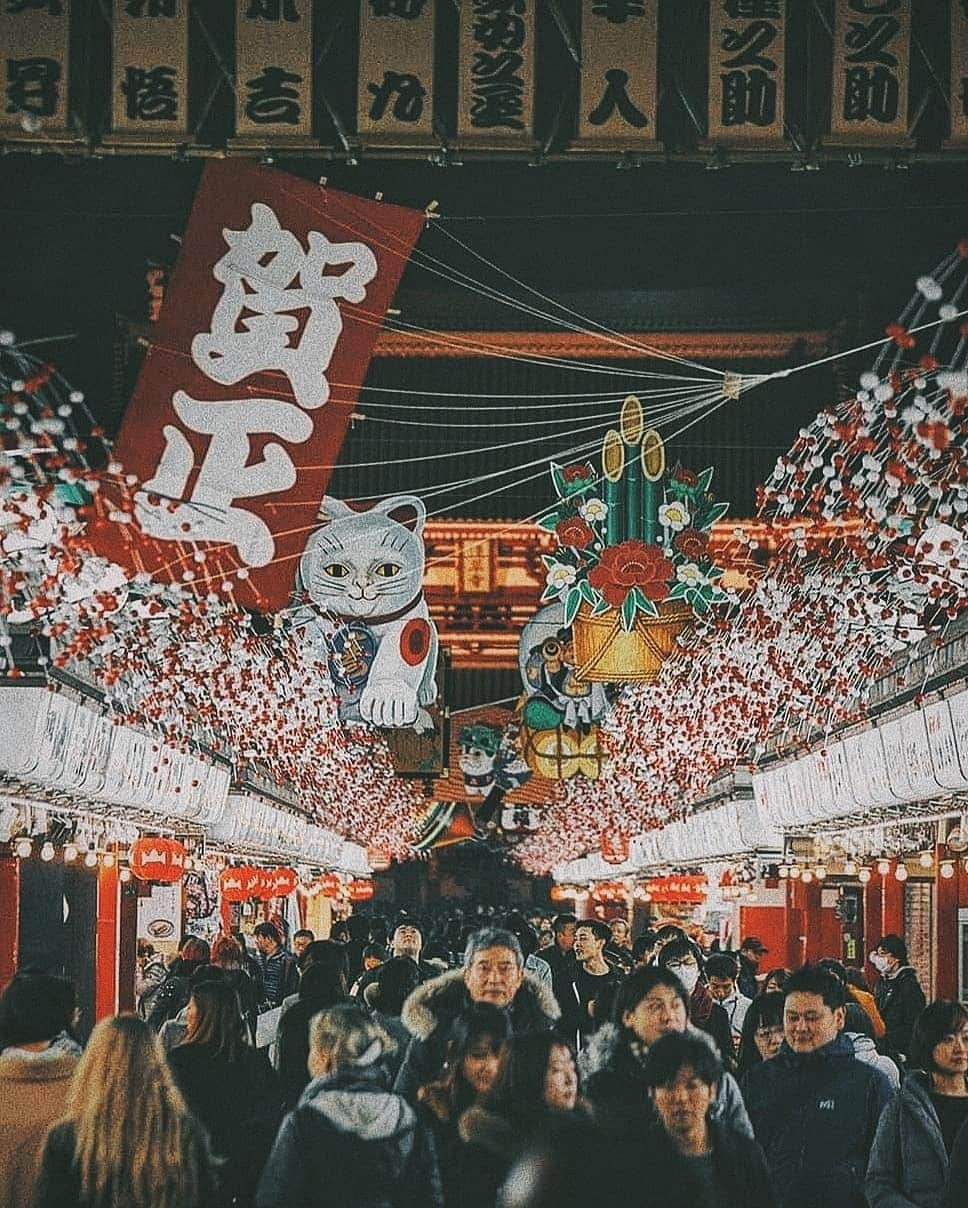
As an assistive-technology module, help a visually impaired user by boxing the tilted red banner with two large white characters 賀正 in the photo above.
[91,161,424,610]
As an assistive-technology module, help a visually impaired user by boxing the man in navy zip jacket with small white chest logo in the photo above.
[743,965,894,1208]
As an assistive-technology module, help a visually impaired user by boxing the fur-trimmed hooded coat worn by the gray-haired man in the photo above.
[393,969,561,1103]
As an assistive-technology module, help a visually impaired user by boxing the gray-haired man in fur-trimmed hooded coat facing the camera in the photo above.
[394,927,561,1099]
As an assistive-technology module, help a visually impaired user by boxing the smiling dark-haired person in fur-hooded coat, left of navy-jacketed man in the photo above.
[579,965,753,1145]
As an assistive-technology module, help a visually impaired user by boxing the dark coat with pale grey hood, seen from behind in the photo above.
[255,1067,444,1208]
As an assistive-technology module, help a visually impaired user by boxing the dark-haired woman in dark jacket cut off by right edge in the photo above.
[864,1000,968,1208]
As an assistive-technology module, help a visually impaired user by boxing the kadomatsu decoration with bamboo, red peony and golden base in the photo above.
[540,395,729,683]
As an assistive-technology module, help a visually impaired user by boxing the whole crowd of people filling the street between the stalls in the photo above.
[0,912,968,1208]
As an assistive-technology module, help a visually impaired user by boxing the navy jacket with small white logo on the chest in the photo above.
[743,1033,894,1208]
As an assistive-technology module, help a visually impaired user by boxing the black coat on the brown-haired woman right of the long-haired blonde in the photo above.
[168,1045,283,1204]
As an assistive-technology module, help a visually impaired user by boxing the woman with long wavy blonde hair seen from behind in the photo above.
[34,1015,218,1208]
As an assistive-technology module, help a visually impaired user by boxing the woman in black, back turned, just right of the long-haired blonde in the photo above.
[168,981,282,1208]
